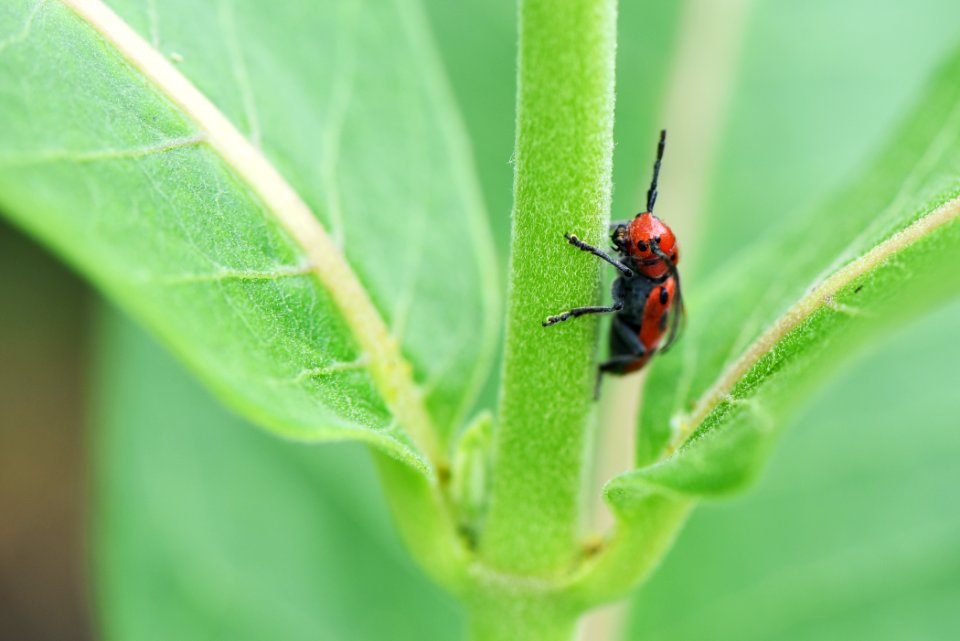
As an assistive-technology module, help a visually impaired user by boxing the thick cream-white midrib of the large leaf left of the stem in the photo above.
[61,0,441,472]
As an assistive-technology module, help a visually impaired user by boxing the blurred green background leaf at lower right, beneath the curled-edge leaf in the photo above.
[622,302,960,641]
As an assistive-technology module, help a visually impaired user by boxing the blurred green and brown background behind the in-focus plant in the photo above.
[0,0,960,641]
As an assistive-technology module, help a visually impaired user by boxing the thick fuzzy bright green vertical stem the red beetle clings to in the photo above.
[481,0,616,576]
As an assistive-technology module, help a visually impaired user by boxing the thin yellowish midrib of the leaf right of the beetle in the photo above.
[658,192,960,462]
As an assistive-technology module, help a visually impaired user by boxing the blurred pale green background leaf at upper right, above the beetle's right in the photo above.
[688,0,960,276]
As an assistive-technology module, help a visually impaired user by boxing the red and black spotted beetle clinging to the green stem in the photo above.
[543,130,684,392]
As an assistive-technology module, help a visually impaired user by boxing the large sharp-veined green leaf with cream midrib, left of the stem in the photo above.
[0,0,498,469]
